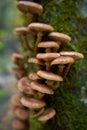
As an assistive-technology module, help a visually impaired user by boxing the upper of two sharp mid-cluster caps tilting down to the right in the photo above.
[37,70,63,81]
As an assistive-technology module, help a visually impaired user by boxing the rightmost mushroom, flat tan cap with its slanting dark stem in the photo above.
[60,51,84,78]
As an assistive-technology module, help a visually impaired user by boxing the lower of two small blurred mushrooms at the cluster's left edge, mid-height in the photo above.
[9,67,25,79]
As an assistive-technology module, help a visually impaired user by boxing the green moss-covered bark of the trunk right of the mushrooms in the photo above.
[21,0,87,130]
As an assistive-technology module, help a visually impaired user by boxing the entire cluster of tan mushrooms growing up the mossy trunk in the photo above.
[10,0,84,130]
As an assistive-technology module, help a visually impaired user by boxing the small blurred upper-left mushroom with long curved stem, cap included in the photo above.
[14,27,33,51]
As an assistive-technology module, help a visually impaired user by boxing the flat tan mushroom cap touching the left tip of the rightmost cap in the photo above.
[36,53,60,61]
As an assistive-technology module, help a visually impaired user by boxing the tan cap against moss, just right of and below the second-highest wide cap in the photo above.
[48,32,71,42]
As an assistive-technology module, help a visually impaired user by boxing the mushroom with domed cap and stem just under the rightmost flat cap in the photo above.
[51,56,74,75]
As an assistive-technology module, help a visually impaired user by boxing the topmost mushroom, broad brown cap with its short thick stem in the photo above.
[17,1,43,23]
